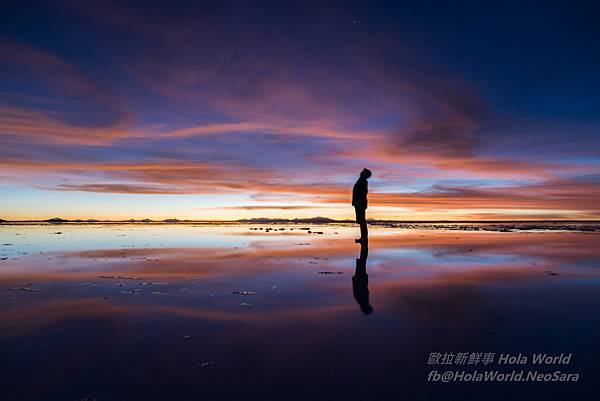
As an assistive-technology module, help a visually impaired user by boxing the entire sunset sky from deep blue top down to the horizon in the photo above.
[0,1,600,220]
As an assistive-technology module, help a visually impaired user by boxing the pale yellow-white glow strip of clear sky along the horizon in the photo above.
[0,188,597,221]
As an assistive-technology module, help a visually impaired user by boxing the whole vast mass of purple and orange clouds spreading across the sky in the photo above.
[0,2,599,216]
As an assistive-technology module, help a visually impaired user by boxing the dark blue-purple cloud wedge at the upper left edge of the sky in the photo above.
[0,36,127,128]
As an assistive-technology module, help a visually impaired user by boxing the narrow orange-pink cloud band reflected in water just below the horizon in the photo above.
[2,230,597,283]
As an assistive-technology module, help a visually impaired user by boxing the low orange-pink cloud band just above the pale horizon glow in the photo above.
[0,155,600,216]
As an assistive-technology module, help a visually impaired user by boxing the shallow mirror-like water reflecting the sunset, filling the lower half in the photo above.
[0,225,600,401]
